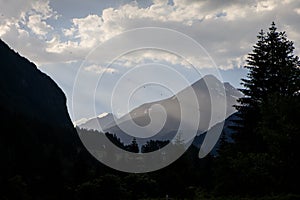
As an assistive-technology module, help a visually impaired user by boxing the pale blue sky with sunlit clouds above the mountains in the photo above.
[0,0,300,121]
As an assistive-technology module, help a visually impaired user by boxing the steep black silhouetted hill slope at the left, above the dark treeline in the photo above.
[0,40,72,127]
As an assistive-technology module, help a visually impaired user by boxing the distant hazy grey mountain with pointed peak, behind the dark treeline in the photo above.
[79,75,242,145]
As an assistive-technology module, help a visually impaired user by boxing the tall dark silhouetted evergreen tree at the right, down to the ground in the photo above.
[215,22,300,195]
